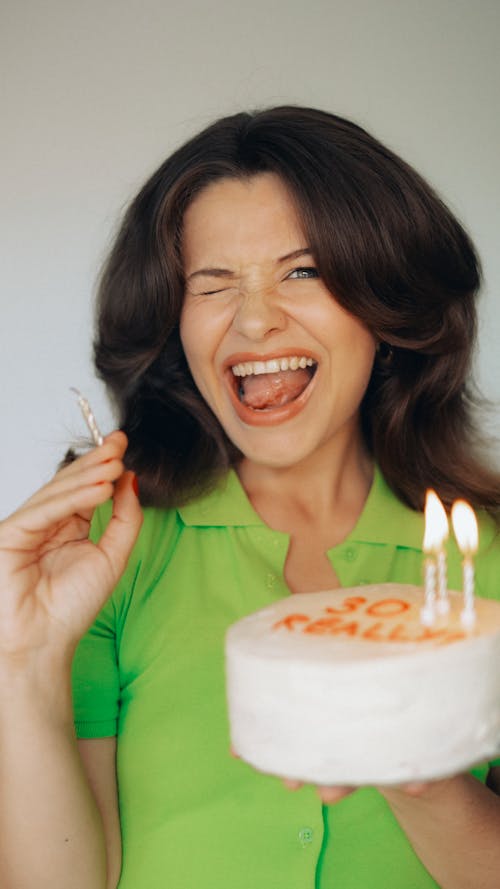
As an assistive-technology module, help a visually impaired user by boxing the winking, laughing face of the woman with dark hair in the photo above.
[180,173,375,467]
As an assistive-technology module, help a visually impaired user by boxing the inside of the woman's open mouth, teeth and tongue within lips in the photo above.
[231,355,317,412]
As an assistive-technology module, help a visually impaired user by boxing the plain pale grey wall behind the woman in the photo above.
[0,0,500,516]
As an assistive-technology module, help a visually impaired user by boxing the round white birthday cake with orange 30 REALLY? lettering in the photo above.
[226,584,500,785]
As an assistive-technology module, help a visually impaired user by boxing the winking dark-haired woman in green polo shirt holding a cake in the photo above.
[0,107,500,889]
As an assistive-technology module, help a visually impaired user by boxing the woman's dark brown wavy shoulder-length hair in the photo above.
[94,106,500,512]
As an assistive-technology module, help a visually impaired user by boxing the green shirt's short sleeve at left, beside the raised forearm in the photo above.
[72,504,120,738]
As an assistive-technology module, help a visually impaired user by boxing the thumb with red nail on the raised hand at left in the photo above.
[97,472,143,582]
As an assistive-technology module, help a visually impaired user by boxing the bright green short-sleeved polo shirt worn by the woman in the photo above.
[74,472,500,889]
